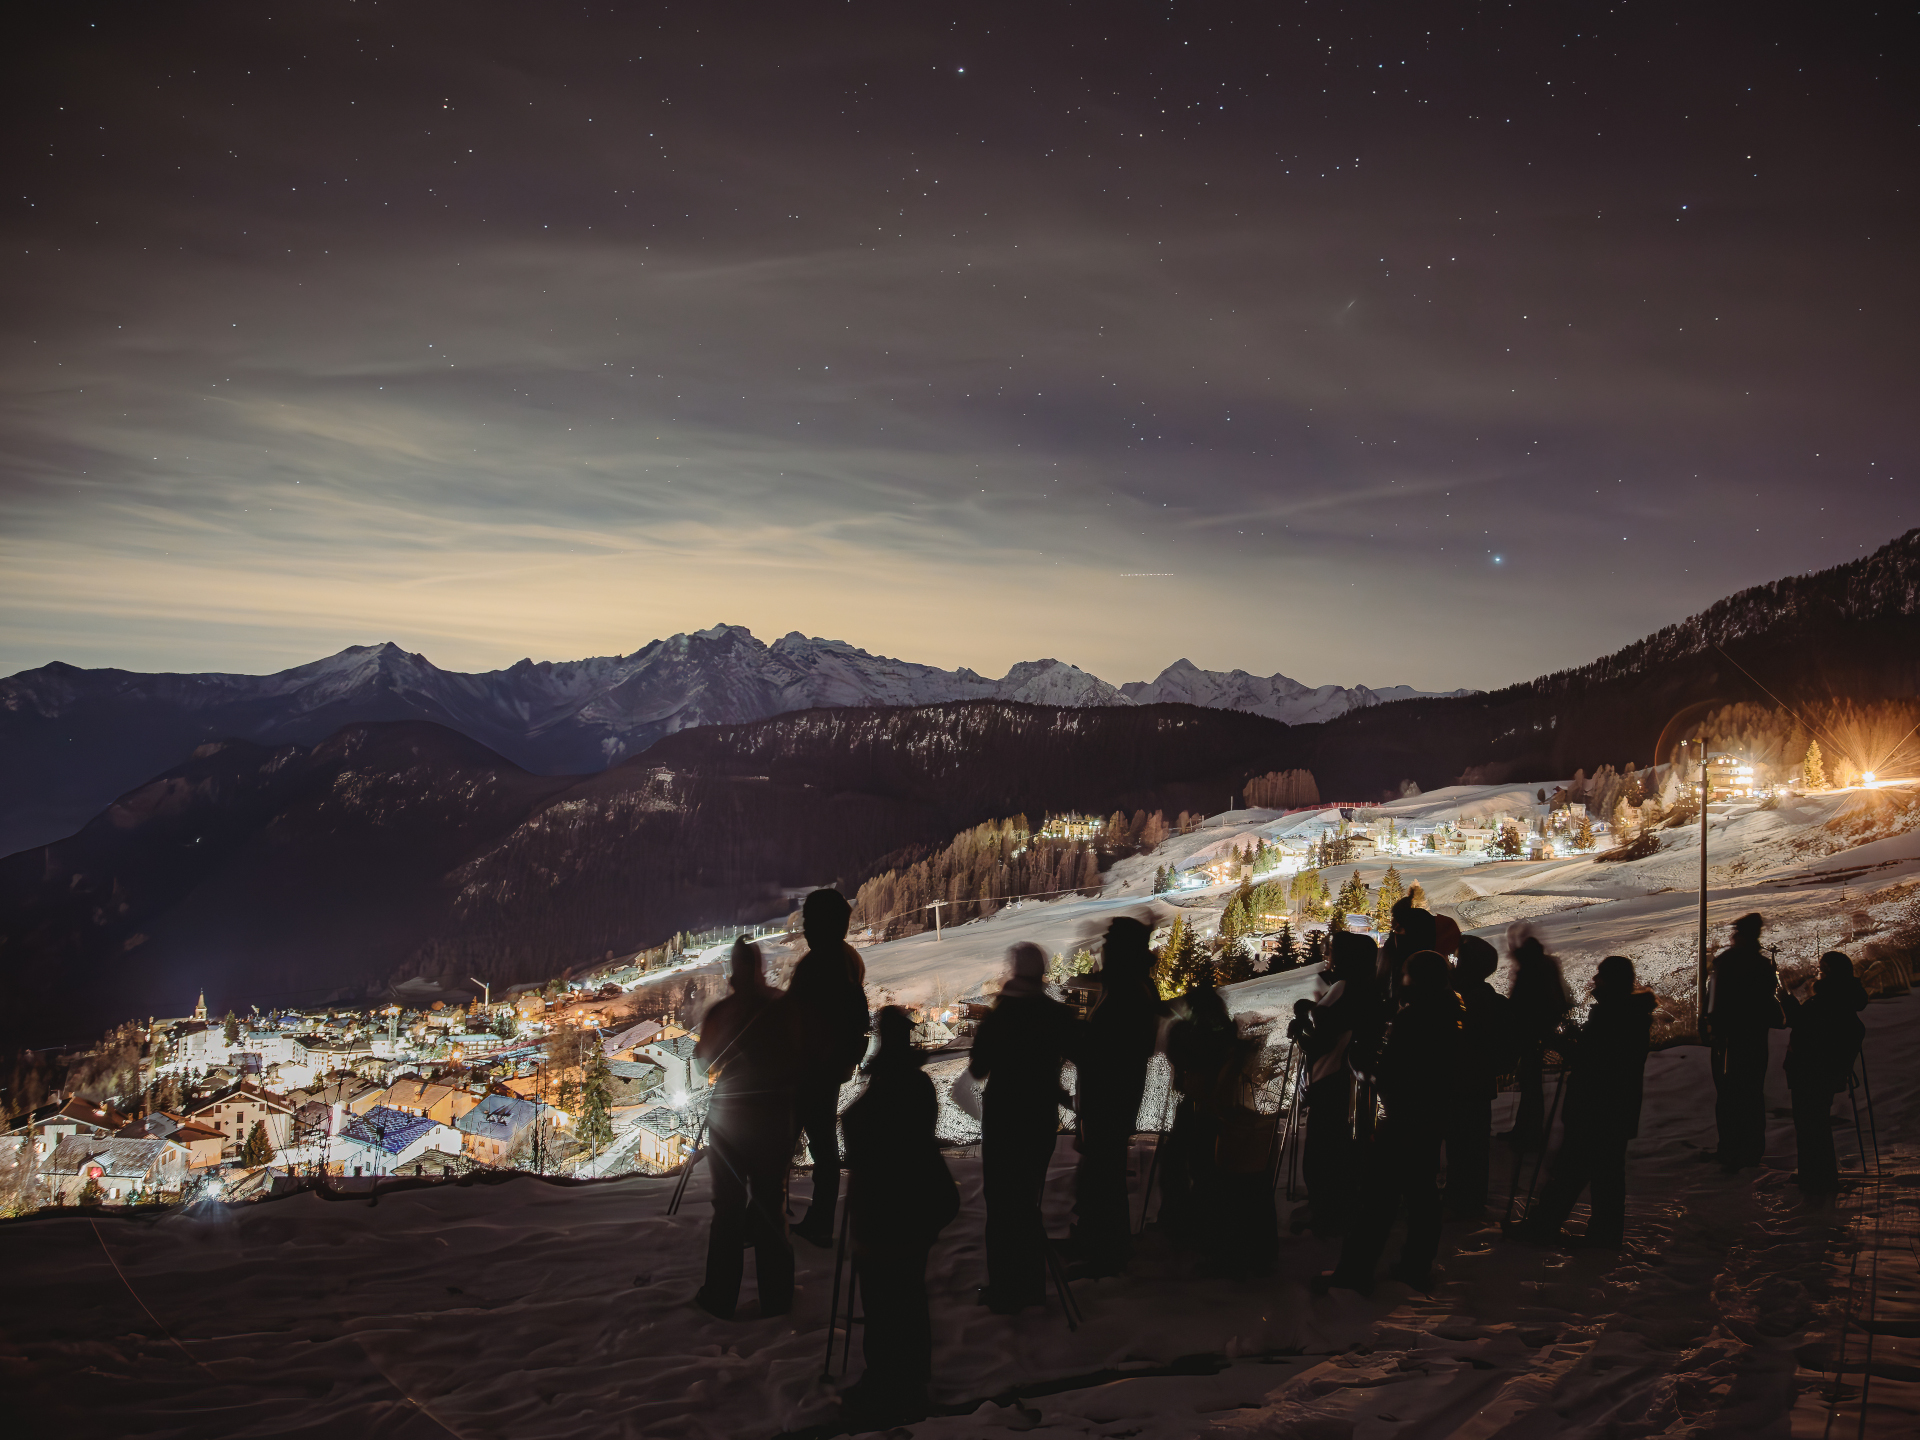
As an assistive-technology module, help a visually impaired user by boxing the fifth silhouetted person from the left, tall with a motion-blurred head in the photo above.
[1073,916,1165,1277]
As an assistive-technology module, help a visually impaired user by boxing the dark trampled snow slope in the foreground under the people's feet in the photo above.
[0,996,1920,1440]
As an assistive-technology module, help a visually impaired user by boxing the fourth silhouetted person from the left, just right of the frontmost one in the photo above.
[968,941,1081,1315]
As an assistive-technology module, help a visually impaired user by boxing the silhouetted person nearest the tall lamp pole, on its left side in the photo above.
[1511,954,1655,1246]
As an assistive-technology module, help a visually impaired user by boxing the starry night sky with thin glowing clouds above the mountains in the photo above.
[0,0,1920,687]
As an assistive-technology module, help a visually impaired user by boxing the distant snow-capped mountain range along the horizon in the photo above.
[0,624,1467,854]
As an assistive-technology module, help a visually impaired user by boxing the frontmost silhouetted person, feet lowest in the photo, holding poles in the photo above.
[841,1004,960,1430]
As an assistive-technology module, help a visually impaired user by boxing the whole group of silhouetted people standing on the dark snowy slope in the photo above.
[695,889,1866,1423]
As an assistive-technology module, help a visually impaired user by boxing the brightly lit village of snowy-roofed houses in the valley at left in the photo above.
[0,985,725,1208]
